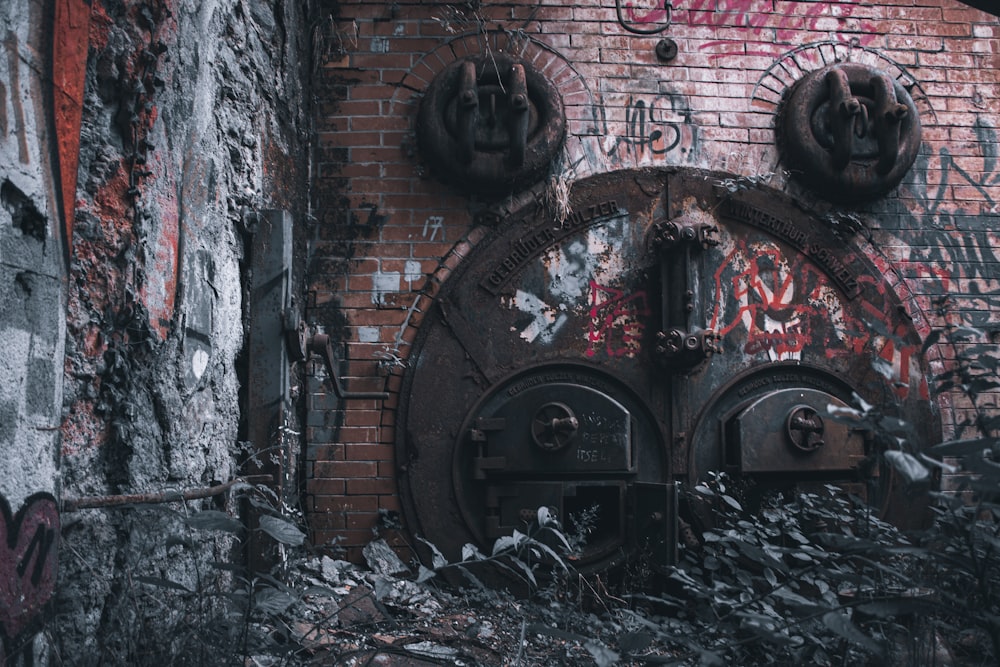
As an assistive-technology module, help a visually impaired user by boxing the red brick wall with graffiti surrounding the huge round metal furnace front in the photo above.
[306,0,1000,553]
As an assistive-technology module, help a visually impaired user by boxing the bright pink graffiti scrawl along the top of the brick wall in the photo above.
[672,0,880,58]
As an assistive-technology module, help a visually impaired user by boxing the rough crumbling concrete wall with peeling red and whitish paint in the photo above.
[44,0,308,664]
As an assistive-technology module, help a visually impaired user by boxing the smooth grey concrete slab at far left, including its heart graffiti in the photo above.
[0,2,67,661]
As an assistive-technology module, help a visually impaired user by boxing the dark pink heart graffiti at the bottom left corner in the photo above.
[0,493,59,664]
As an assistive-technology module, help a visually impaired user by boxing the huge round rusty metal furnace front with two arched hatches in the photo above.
[397,170,933,567]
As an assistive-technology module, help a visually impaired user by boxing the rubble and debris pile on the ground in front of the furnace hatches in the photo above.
[246,540,622,667]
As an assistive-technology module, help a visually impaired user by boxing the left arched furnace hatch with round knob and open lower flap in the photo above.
[452,363,665,565]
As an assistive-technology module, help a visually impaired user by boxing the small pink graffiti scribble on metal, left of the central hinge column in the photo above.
[587,280,650,357]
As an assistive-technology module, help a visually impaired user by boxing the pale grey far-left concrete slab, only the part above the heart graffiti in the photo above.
[0,3,66,509]
